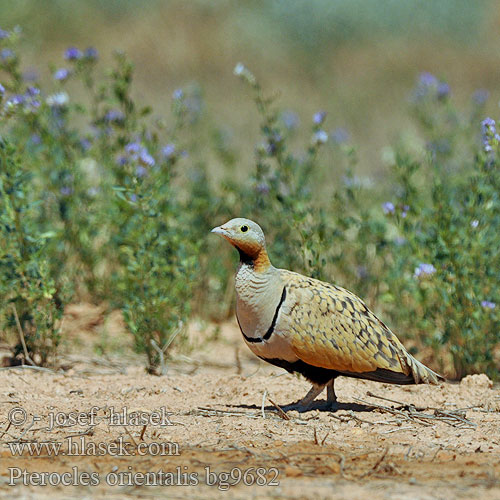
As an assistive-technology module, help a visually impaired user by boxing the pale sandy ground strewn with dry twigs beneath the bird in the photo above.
[0,302,500,500]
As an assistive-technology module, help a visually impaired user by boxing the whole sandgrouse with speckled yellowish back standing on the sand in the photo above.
[211,217,445,411]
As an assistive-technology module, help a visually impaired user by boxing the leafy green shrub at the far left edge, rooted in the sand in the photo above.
[0,140,64,365]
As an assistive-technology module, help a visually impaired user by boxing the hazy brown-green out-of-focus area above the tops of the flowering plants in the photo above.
[0,0,500,174]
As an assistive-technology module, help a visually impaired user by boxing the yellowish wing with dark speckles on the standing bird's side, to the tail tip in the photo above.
[280,269,440,383]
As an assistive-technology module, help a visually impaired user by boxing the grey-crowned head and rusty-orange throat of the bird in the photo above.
[212,218,270,271]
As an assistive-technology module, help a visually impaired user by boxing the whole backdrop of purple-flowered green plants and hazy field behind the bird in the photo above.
[0,0,500,378]
